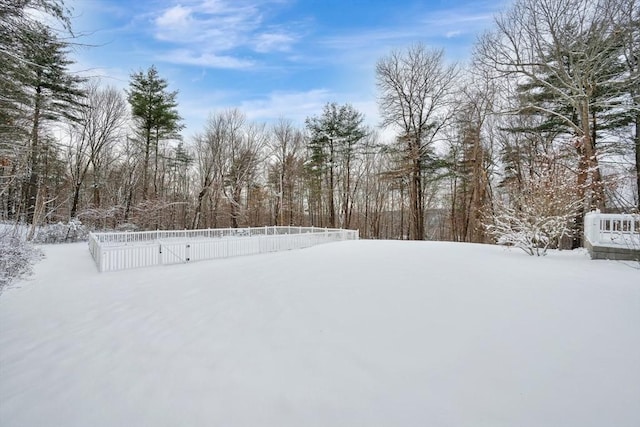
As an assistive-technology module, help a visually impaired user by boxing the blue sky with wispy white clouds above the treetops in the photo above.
[67,0,504,138]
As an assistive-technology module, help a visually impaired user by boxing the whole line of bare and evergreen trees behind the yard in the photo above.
[0,0,640,242]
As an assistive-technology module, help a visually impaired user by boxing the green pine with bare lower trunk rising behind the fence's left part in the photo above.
[127,66,182,200]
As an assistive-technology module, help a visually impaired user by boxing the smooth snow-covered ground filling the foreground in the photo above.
[0,241,640,427]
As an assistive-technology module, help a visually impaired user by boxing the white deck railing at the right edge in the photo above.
[584,211,640,249]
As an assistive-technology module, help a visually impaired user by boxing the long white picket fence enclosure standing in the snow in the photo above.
[89,227,359,271]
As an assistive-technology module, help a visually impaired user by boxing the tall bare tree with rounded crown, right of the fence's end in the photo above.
[376,44,458,240]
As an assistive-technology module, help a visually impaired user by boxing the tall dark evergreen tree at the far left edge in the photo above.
[0,0,71,222]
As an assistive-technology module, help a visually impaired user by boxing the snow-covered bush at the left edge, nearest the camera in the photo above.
[0,229,42,292]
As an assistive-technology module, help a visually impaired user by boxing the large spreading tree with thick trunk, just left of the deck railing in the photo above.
[478,0,632,213]
